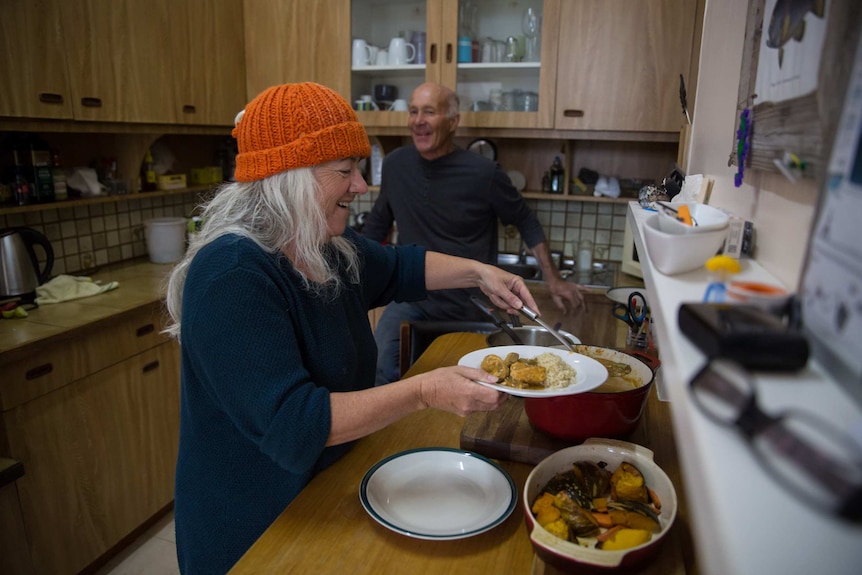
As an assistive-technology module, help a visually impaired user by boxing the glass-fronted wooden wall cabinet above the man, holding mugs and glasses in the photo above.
[352,0,560,128]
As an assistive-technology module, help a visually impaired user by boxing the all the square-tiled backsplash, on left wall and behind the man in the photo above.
[0,191,626,275]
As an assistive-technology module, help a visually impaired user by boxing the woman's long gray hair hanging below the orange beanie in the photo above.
[165,168,359,339]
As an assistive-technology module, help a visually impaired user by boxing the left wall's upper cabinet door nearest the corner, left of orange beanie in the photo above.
[172,0,246,126]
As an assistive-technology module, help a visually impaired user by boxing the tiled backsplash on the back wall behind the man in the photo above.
[353,191,627,262]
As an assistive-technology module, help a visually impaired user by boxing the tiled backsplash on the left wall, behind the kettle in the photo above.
[0,192,198,275]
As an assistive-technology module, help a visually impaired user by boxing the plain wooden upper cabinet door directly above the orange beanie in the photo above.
[244,0,350,100]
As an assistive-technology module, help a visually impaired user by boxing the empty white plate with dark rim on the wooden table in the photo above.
[359,447,518,540]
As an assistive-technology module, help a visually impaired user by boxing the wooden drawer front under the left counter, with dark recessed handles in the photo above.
[0,304,169,411]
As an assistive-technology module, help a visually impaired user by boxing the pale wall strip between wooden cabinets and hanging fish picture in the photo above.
[688,0,818,289]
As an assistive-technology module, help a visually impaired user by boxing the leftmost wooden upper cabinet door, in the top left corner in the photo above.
[0,0,72,119]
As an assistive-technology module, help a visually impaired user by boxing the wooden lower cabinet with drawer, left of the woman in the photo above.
[0,304,180,575]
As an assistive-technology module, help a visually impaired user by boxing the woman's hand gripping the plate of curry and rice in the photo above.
[416,366,508,417]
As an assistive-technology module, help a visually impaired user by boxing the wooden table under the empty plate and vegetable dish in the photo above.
[231,333,694,575]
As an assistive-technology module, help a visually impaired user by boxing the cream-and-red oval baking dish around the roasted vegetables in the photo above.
[522,438,677,573]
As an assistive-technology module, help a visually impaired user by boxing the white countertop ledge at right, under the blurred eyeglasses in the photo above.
[628,202,862,575]
